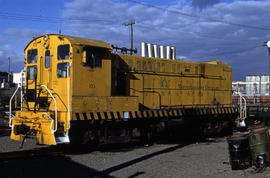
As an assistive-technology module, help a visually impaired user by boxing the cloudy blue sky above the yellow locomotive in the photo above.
[0,0,270,81]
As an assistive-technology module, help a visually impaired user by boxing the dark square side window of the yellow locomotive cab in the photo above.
[83,47,104,68]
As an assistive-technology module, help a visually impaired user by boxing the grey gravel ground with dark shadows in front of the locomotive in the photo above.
[0,129,270,178]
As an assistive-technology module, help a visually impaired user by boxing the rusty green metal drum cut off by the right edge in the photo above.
[249,127,270,163]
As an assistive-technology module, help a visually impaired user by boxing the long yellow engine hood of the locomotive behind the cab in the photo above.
[116,54,232,108]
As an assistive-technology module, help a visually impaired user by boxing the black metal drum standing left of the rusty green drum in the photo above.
[227,136,252,170]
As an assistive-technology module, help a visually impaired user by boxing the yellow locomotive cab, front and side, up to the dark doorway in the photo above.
[10,35,134,145]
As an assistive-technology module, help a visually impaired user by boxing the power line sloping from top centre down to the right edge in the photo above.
[128,0,270,31]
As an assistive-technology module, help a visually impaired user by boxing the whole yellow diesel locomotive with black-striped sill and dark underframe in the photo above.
[9,34,238,145]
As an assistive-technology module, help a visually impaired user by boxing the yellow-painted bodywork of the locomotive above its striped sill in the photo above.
[11,35,231,145]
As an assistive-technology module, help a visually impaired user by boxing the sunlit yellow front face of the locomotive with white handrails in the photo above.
[10,35,73,145]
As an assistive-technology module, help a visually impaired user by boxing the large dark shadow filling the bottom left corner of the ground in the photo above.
[0,150,111,178]
